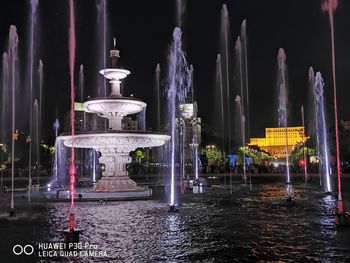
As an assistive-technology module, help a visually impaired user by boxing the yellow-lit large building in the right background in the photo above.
[248,126,309,158]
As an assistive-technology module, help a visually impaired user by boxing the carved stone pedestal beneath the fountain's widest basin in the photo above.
[93,148,142,192]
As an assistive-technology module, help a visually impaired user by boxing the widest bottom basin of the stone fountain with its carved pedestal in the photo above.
[57,131,171,192]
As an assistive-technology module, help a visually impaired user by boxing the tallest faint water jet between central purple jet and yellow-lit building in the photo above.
[221,4,231,154]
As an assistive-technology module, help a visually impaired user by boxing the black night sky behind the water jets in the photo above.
[0,0,350,144]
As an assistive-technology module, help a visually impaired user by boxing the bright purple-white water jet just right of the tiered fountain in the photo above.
[167,27,191,210]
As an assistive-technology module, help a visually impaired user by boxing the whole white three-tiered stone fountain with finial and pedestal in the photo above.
[58,41,170,196]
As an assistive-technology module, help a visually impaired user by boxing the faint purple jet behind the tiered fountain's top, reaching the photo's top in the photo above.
[96,0,109,97]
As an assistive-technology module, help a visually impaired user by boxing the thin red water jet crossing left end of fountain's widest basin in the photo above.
[69,0,75,231]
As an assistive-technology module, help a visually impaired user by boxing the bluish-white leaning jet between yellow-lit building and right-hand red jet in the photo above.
[314,72,332,192]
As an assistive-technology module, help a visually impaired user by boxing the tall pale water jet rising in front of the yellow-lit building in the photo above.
[277,48,293,201]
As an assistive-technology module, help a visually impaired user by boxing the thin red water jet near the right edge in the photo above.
[322,0,344,219]
